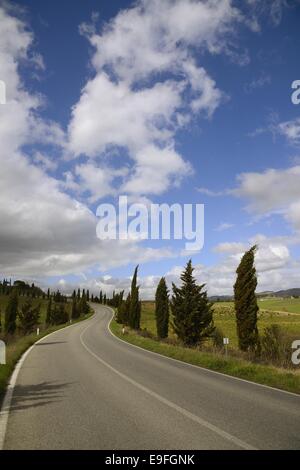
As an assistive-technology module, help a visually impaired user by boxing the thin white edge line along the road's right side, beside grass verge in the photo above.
[105,307,300,398]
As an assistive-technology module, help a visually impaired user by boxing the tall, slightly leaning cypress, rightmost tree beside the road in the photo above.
[234,245,259,351]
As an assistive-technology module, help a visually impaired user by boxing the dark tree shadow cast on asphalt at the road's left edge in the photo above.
[10,382,72,411]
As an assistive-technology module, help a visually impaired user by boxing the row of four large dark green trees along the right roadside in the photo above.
[116,245,260,352]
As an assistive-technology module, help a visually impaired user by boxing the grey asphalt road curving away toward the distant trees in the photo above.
[4,306,300,450]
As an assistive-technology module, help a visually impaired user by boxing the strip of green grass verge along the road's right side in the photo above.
[110,320,300,394]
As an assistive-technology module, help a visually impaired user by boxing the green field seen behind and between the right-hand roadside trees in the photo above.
[141,299,300,348]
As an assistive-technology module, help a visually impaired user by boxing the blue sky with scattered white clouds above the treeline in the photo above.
[0,0,300,299]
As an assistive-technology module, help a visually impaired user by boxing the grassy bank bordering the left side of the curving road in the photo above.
[0,306,94,407]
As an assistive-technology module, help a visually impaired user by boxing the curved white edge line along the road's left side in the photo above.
[0,314,95,451]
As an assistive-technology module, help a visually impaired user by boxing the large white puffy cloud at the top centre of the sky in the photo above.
[68,0,251,195]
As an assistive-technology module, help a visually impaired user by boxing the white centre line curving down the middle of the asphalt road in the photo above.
[80,318,257,450]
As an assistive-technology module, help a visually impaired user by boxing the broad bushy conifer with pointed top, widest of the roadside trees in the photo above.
[171,260,215,346]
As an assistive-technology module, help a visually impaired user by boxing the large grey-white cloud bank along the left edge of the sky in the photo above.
[0,6,172,276]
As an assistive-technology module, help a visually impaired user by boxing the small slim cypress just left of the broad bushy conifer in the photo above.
[155,277,169,338]
